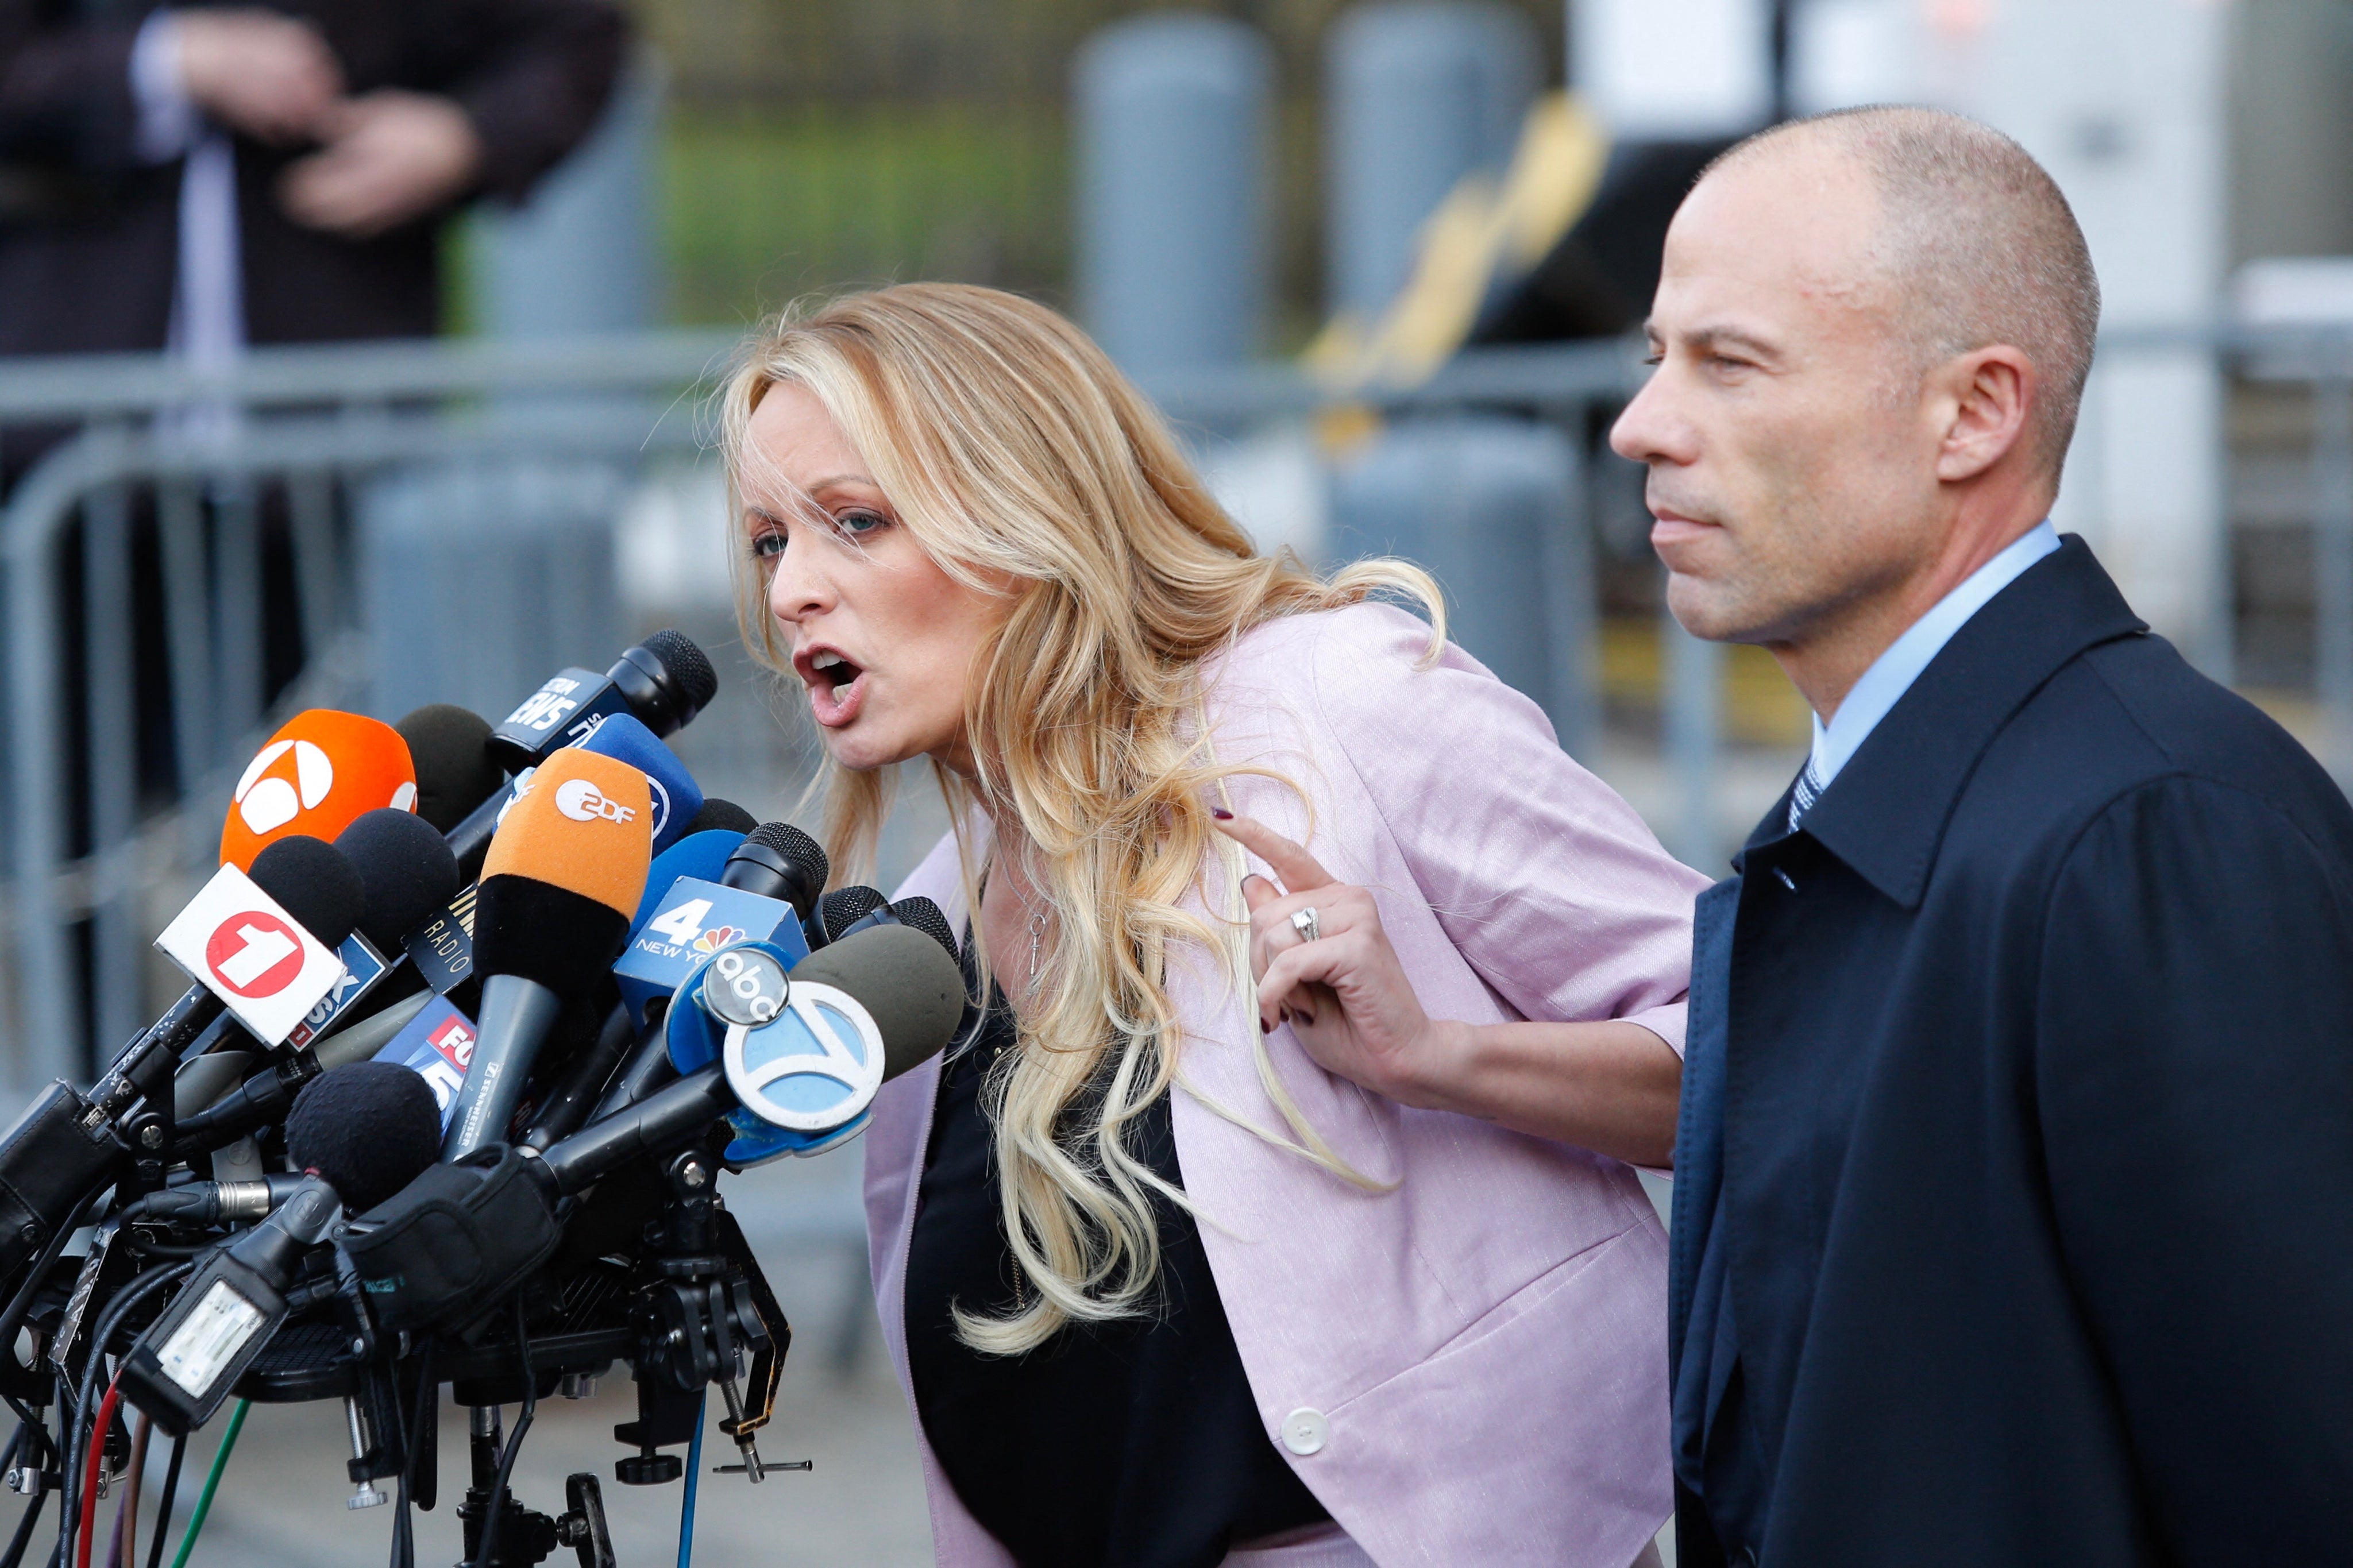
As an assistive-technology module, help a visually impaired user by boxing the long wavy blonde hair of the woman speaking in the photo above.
[722,284,1442,1354]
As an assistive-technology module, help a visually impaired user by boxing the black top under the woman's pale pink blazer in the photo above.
[906,992,1329,1568]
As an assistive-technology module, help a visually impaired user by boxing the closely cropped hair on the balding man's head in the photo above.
[1701,106,2099,482]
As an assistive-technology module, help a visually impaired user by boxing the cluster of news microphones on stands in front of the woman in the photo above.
[0,632,967,1568]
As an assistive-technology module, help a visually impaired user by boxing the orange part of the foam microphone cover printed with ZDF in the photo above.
[475,745,654,921]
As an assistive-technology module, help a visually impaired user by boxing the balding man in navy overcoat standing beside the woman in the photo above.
[1612,110,2353,1568]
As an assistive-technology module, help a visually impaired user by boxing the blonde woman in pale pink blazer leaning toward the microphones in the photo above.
[725,284,1704,1568]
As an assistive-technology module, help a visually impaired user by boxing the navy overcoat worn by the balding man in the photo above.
[1671,538,2353,1568]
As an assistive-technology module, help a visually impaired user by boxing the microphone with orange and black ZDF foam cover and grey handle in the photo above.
[442,745,654,1159]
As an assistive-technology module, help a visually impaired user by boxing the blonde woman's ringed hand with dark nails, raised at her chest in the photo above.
[1217,813,1459,1105]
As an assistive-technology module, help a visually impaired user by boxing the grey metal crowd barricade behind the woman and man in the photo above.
[14,331,2353,1088]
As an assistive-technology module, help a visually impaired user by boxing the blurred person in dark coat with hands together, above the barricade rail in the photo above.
[0,0,626,381]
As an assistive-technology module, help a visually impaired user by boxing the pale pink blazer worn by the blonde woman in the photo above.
[866,604,1706,1568]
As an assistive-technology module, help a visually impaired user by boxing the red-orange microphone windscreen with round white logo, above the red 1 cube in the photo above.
[221,708,416,872]
